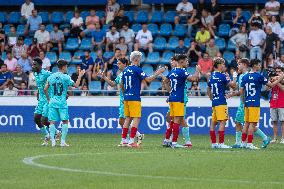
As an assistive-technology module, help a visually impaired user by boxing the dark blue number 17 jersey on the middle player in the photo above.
[167,68,190,102]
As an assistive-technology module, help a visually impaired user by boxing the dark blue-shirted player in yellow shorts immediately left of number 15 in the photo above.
[207,58,237,148]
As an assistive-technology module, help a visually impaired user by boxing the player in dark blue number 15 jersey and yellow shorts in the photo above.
[240,59,284,150]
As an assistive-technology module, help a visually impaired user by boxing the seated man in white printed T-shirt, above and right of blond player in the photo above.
[134,23,153,52]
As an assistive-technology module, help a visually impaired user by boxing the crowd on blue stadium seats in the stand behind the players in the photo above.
[0,0,284,96]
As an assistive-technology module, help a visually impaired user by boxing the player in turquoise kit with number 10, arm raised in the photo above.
[44,60,85,147]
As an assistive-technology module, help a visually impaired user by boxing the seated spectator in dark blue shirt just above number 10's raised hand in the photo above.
[74,50,94,84]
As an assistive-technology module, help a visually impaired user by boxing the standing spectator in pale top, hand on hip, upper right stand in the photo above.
[230,26,248,58]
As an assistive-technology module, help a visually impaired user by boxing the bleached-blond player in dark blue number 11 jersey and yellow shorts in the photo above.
[121,51,166,147]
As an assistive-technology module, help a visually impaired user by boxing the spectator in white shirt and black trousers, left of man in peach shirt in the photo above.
[70,11,84,43]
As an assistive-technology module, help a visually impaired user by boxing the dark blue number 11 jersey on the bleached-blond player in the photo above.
[122,65,148,101]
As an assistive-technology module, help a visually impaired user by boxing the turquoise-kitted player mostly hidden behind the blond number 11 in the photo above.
[100,58,144,146]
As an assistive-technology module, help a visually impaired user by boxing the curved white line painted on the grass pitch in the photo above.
[22,152,284,185]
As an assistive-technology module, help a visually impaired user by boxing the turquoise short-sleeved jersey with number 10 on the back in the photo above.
[47,72,74,108]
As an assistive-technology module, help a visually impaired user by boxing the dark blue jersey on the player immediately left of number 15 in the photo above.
[208,71,230,107]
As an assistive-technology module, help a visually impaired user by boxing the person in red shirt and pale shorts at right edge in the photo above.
[270,67,284,144]
